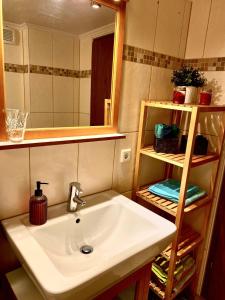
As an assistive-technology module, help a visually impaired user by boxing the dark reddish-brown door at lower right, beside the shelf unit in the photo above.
[202,176,225,300]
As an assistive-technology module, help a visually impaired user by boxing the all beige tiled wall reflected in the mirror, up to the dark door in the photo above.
[5,23,115,128]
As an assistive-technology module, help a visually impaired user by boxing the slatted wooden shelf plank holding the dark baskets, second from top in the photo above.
[140,146,219,168]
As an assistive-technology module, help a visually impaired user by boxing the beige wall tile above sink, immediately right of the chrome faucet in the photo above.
[78,141,115,195]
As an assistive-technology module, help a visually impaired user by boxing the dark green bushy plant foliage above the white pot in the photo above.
[171,66,206,87]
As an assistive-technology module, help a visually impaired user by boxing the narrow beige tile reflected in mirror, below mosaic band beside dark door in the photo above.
[79,78,91,114]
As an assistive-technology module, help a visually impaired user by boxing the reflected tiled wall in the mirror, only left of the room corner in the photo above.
[5,24,79,127]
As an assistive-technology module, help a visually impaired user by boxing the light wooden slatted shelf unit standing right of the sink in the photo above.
[133,100,225,300]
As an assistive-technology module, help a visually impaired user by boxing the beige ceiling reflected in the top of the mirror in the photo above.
[3,0,115,34]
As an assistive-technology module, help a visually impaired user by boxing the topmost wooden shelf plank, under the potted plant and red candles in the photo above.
[144,100,225,112]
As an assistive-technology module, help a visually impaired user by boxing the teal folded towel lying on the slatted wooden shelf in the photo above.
[148,179,206,206]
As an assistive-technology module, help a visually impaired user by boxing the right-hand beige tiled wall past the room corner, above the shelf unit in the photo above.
[186,0,225,104]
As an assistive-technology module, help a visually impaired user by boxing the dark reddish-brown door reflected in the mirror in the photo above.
[90,33,114,126]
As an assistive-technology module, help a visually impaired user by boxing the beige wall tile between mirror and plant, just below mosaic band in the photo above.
[119,61,151,132]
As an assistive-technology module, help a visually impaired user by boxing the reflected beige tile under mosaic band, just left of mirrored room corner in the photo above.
[53,76,74,112]
